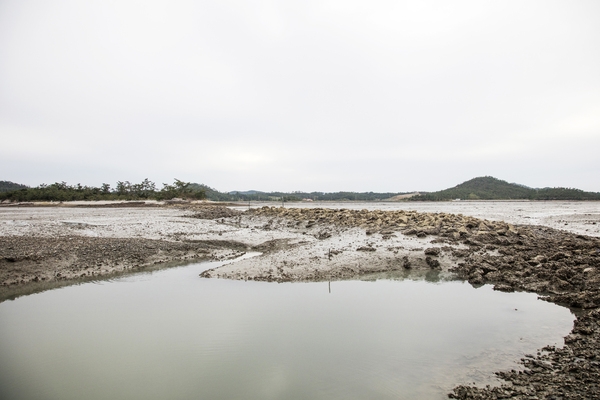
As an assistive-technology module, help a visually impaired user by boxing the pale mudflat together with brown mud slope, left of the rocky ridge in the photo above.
[0,205,253,301]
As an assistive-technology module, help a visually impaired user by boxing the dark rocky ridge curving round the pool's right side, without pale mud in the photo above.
[247,207,600,400]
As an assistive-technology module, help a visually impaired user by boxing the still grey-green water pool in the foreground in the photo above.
[0,263,573,400]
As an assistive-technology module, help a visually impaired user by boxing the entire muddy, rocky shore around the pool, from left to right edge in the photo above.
[0,203,600,399]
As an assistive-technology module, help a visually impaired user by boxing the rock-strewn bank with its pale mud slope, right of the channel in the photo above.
[204,207,600,399]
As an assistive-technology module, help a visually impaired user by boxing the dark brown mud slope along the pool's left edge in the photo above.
[0,236,245,301]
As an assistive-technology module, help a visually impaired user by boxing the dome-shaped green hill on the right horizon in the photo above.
[410,176,600,201]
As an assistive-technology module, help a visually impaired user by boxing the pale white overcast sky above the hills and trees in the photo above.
[0,0,600,192]
